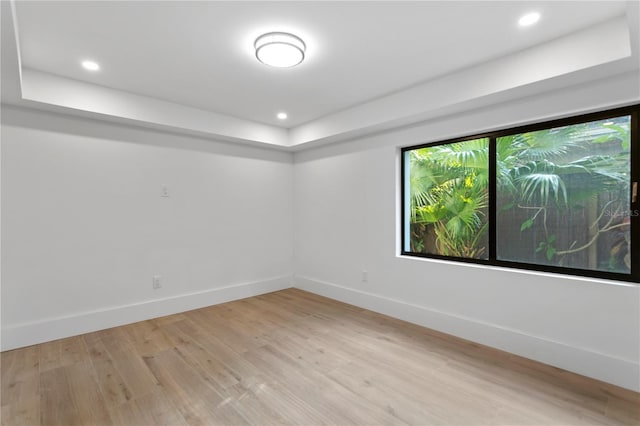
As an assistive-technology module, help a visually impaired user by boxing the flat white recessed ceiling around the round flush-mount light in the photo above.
[3,1,637,150]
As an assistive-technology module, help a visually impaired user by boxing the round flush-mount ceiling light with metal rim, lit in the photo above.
[253,32,307,68]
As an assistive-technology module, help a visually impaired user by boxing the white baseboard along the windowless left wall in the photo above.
[2,275,292,351]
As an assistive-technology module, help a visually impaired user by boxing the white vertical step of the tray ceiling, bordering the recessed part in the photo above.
[2,8,638,150]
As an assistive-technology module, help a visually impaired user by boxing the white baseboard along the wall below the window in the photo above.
[294,276,640,392]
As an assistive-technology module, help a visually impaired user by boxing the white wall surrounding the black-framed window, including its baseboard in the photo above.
[294,71,640,390]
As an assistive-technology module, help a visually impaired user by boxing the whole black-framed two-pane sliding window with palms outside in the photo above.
[402,106,640,282]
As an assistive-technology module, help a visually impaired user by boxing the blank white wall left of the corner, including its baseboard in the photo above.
[1,105,293,350]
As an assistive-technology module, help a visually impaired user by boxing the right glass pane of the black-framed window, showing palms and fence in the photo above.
[496,116,631,273]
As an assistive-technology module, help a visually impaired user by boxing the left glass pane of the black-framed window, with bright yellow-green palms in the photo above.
[405,138,489,259]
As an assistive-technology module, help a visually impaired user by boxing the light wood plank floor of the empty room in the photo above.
[1,289,640,426]
